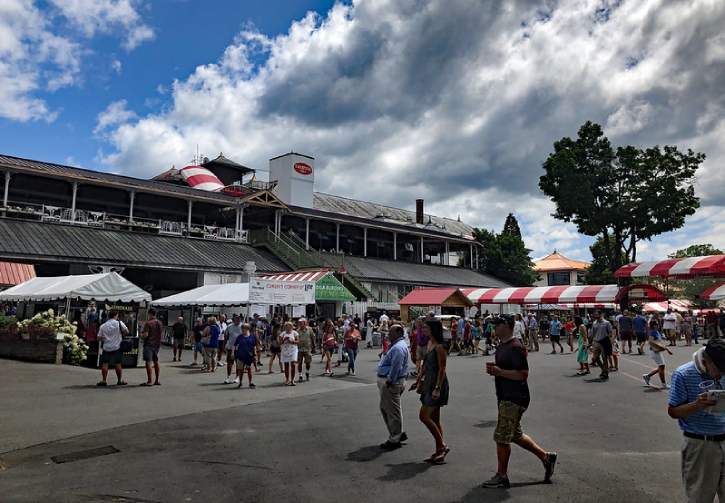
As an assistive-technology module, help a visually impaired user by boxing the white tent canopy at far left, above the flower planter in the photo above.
[0,272,151,302]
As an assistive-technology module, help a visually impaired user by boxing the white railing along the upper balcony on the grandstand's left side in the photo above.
[0,201,249,243]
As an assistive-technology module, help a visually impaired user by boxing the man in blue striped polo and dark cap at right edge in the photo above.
[667,339,725,503]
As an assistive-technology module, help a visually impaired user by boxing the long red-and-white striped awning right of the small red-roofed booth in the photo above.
[463,285,619,304]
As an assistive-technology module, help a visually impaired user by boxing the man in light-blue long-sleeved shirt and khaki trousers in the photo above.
[378,323,410,451]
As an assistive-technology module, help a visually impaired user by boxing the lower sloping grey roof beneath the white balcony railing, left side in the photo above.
[0,219,287,273]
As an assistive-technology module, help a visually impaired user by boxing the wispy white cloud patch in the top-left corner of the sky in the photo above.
[0,0,153,121]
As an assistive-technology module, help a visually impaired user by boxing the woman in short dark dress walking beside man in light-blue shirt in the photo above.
[410,320,450,464]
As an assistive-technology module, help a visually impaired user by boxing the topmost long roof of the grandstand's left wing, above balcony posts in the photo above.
[0,155,238,206]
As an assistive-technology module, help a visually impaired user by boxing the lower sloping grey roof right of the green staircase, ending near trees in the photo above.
[325,254,511,288]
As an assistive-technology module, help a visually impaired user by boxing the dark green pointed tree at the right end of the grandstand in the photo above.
[473,214,538,286]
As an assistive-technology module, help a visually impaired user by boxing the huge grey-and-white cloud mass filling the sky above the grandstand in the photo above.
[103,0,725,258]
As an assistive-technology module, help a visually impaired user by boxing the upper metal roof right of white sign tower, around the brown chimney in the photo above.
[310,192,473,239]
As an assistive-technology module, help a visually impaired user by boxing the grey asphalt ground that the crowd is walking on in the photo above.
[0,346,704,503]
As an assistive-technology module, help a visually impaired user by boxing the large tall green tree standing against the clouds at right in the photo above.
[539,121,705,271]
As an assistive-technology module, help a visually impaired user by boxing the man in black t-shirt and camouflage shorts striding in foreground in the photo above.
[483,316,557,488]
